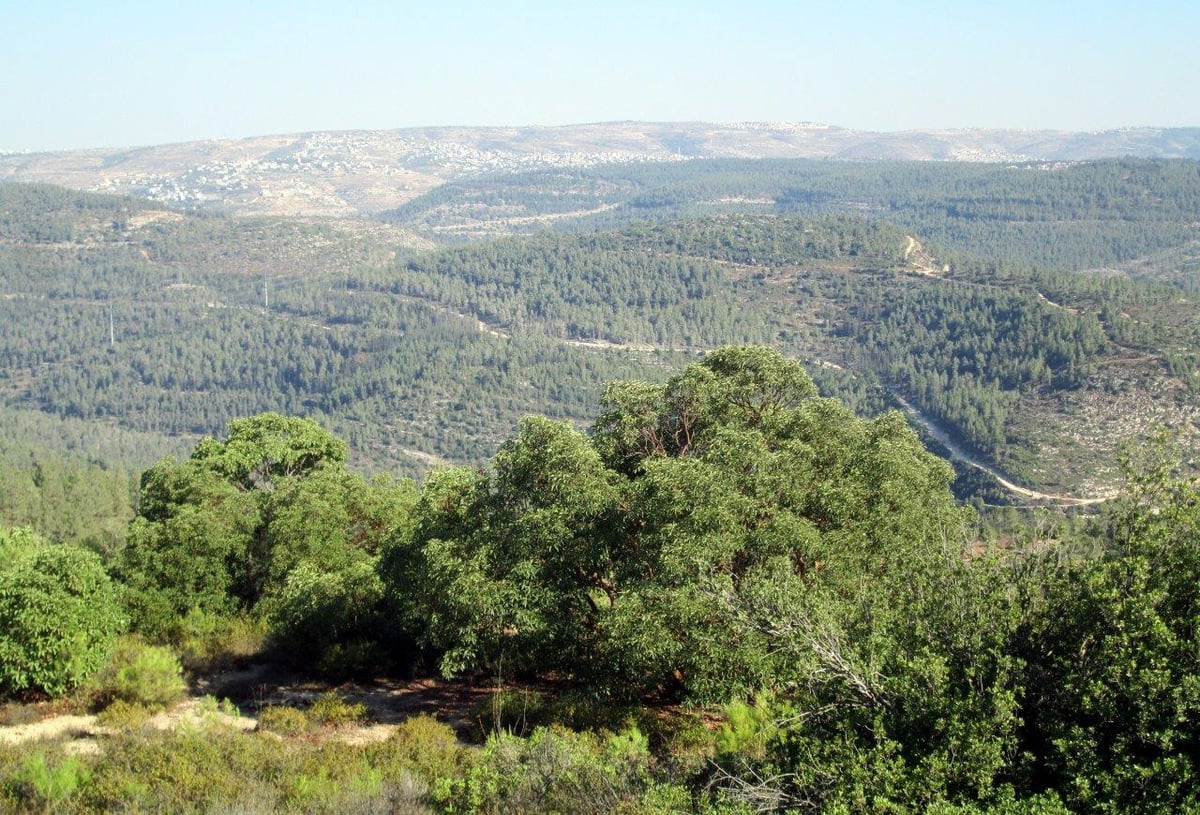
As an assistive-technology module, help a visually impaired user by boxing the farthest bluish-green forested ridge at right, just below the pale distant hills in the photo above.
[390,160,1200,270]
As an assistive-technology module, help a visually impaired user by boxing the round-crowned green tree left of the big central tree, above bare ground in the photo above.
[121,414,414,672]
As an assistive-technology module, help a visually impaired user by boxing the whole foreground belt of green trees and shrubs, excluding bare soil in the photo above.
[7,347,1200,813]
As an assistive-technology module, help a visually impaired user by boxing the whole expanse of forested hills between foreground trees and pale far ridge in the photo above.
[0,161,1200,497]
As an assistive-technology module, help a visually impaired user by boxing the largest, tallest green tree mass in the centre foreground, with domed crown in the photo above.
[386,347,962,699]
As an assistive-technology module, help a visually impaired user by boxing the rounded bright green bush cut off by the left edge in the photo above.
[0,529,125,696]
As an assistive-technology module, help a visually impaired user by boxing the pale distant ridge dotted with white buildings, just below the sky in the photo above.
[0,122,1200,216]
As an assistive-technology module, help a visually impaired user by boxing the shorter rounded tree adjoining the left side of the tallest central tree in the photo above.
[398,418,617,671]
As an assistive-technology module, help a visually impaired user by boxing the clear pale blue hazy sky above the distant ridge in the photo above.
[0,0,1200,150]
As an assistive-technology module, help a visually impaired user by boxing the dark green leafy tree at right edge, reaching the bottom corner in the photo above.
[1021,436,1200,813]
